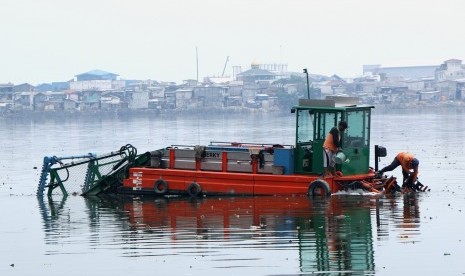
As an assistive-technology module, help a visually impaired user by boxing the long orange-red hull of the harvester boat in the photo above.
[122,167,373,195]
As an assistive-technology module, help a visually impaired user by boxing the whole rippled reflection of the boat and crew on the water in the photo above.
[39,194,420,273]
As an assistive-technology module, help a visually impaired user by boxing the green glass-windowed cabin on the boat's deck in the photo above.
[292,97,373,176]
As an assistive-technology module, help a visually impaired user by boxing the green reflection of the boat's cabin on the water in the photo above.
[300,197,376,272]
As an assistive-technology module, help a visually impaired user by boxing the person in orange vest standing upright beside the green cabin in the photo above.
[323,121,348,176]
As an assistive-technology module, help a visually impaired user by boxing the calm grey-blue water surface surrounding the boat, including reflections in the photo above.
[0,110,465,275]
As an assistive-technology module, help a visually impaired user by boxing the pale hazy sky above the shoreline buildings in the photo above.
[0,0,465,84]
